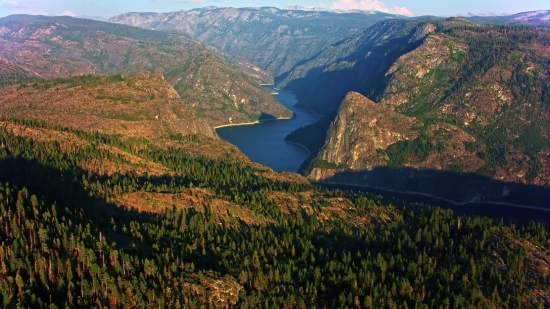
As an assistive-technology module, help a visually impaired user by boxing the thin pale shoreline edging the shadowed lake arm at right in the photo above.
[310,181,550,212]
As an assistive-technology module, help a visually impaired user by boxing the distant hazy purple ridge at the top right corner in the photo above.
[466,10,550,29]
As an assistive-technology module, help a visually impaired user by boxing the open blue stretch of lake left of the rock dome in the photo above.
[216,87,321,172]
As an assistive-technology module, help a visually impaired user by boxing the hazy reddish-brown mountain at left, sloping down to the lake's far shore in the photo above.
[0,15,292,126]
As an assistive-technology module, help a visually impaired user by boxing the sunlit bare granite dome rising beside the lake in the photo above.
[319,92,422,170]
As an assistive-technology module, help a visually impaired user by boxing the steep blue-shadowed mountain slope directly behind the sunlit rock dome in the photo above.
[277,20,424,116]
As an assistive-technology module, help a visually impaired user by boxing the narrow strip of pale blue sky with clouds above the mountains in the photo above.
[0,0,550,17]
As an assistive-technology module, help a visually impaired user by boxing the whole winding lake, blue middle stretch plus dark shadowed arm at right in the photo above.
[216,87,550,224]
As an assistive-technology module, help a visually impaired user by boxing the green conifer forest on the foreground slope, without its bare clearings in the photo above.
[0,116,550,308]
